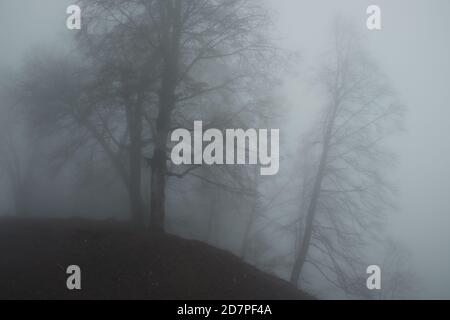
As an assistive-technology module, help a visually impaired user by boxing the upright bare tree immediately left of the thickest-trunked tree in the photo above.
[77,13,161,225]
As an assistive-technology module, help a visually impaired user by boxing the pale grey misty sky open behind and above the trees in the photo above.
[0,0,450,298]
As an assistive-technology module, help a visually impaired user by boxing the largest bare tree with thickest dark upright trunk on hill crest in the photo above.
[78,0,275,232]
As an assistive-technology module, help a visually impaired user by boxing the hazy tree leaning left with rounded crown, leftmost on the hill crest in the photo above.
[14,52,144,225]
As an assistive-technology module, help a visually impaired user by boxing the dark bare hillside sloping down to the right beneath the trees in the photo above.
[0,218,310,300]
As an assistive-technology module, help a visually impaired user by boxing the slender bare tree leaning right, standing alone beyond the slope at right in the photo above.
[291,20,403,292]
